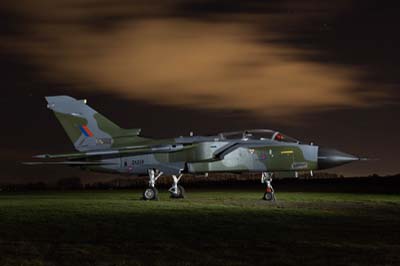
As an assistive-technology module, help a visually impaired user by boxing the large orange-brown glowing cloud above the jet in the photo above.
[4,0,363,116]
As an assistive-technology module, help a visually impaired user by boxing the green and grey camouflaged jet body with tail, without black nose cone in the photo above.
[37,96,328,175]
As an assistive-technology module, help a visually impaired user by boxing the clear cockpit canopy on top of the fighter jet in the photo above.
[218,129,300,143]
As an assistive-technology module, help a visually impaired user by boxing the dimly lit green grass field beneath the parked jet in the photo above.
[0,190,400,266]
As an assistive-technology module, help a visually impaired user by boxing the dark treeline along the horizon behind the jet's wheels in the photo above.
[0,173,400,193]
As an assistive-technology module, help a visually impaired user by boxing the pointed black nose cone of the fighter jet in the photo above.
[318,147,360,169]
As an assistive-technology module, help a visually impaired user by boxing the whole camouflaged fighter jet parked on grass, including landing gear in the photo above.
[27,96,360,201]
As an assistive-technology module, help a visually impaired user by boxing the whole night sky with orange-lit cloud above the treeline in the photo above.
[0,0,400,182]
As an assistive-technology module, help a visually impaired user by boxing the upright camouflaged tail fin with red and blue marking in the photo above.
[46,96,140,151]
